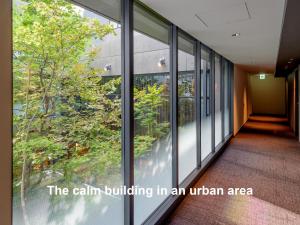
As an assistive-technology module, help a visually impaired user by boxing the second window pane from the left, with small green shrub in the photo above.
[134,4,172,224]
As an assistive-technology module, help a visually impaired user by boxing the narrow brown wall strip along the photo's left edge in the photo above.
[0,0,12,225]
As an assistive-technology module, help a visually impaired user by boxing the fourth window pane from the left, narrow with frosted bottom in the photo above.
[201,46,212,161]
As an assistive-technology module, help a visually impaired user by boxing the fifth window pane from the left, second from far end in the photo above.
[215,55,222,146]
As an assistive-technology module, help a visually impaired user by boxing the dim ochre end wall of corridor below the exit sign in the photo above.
[249,74,286,116]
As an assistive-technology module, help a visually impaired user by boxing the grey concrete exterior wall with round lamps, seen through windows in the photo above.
[93,28,195,76]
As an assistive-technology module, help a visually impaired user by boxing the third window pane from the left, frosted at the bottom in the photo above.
[178,32,197,183]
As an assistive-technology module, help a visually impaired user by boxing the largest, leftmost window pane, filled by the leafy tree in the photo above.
[13,0,123,225]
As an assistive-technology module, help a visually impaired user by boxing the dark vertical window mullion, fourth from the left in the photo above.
[210,51,216,153]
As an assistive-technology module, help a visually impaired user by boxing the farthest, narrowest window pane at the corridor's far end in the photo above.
[224,60,230,137]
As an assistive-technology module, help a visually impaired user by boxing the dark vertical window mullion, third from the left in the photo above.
[195,41,201,168]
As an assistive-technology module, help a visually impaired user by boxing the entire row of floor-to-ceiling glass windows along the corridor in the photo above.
[13,0,232,225]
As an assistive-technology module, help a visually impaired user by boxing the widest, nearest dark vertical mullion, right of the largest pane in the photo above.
[121,0,134,225]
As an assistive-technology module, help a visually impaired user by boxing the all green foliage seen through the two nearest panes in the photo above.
[13,0,168,193]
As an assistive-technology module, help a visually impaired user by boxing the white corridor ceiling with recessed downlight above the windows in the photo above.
[142,0,285,72]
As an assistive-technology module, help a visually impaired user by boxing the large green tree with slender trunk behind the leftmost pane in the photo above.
[13,0,116,224]
